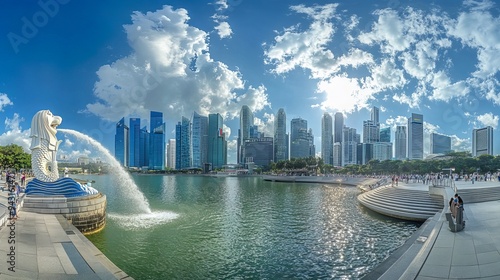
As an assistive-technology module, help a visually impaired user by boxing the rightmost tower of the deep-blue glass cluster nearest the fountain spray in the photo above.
[149,111,165,170]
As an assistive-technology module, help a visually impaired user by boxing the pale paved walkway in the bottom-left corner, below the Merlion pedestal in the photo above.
[0,184,132,279]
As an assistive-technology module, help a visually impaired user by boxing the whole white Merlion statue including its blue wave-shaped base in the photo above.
[26,110,98,197]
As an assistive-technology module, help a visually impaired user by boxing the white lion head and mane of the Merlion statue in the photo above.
[30,110,62,151]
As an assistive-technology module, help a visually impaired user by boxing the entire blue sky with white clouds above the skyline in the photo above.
[0,0,500,162]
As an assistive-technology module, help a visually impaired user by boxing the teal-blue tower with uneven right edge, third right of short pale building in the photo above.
[207,113,227,170]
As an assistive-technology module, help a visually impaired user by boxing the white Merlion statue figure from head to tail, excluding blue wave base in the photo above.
[30,110,62,182]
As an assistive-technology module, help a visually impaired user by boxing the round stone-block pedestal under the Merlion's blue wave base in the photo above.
[22,193,106,234]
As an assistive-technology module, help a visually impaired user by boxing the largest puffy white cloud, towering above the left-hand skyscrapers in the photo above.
[87,6,269,121]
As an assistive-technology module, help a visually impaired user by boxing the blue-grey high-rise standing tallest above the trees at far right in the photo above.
[408,113,424,160]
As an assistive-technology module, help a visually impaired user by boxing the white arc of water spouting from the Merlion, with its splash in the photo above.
[57,128,179,230]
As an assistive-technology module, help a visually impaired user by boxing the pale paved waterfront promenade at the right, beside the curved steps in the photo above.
[364,181,500,280]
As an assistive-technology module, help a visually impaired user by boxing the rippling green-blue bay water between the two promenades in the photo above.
[80,175,419,279]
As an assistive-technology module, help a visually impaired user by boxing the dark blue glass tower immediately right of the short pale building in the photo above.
[175,117,191,170]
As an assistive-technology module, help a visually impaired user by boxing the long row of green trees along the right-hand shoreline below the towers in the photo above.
[270,152,500,175]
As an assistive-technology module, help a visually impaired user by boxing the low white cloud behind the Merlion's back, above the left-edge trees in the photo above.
[0,113,31,153]
